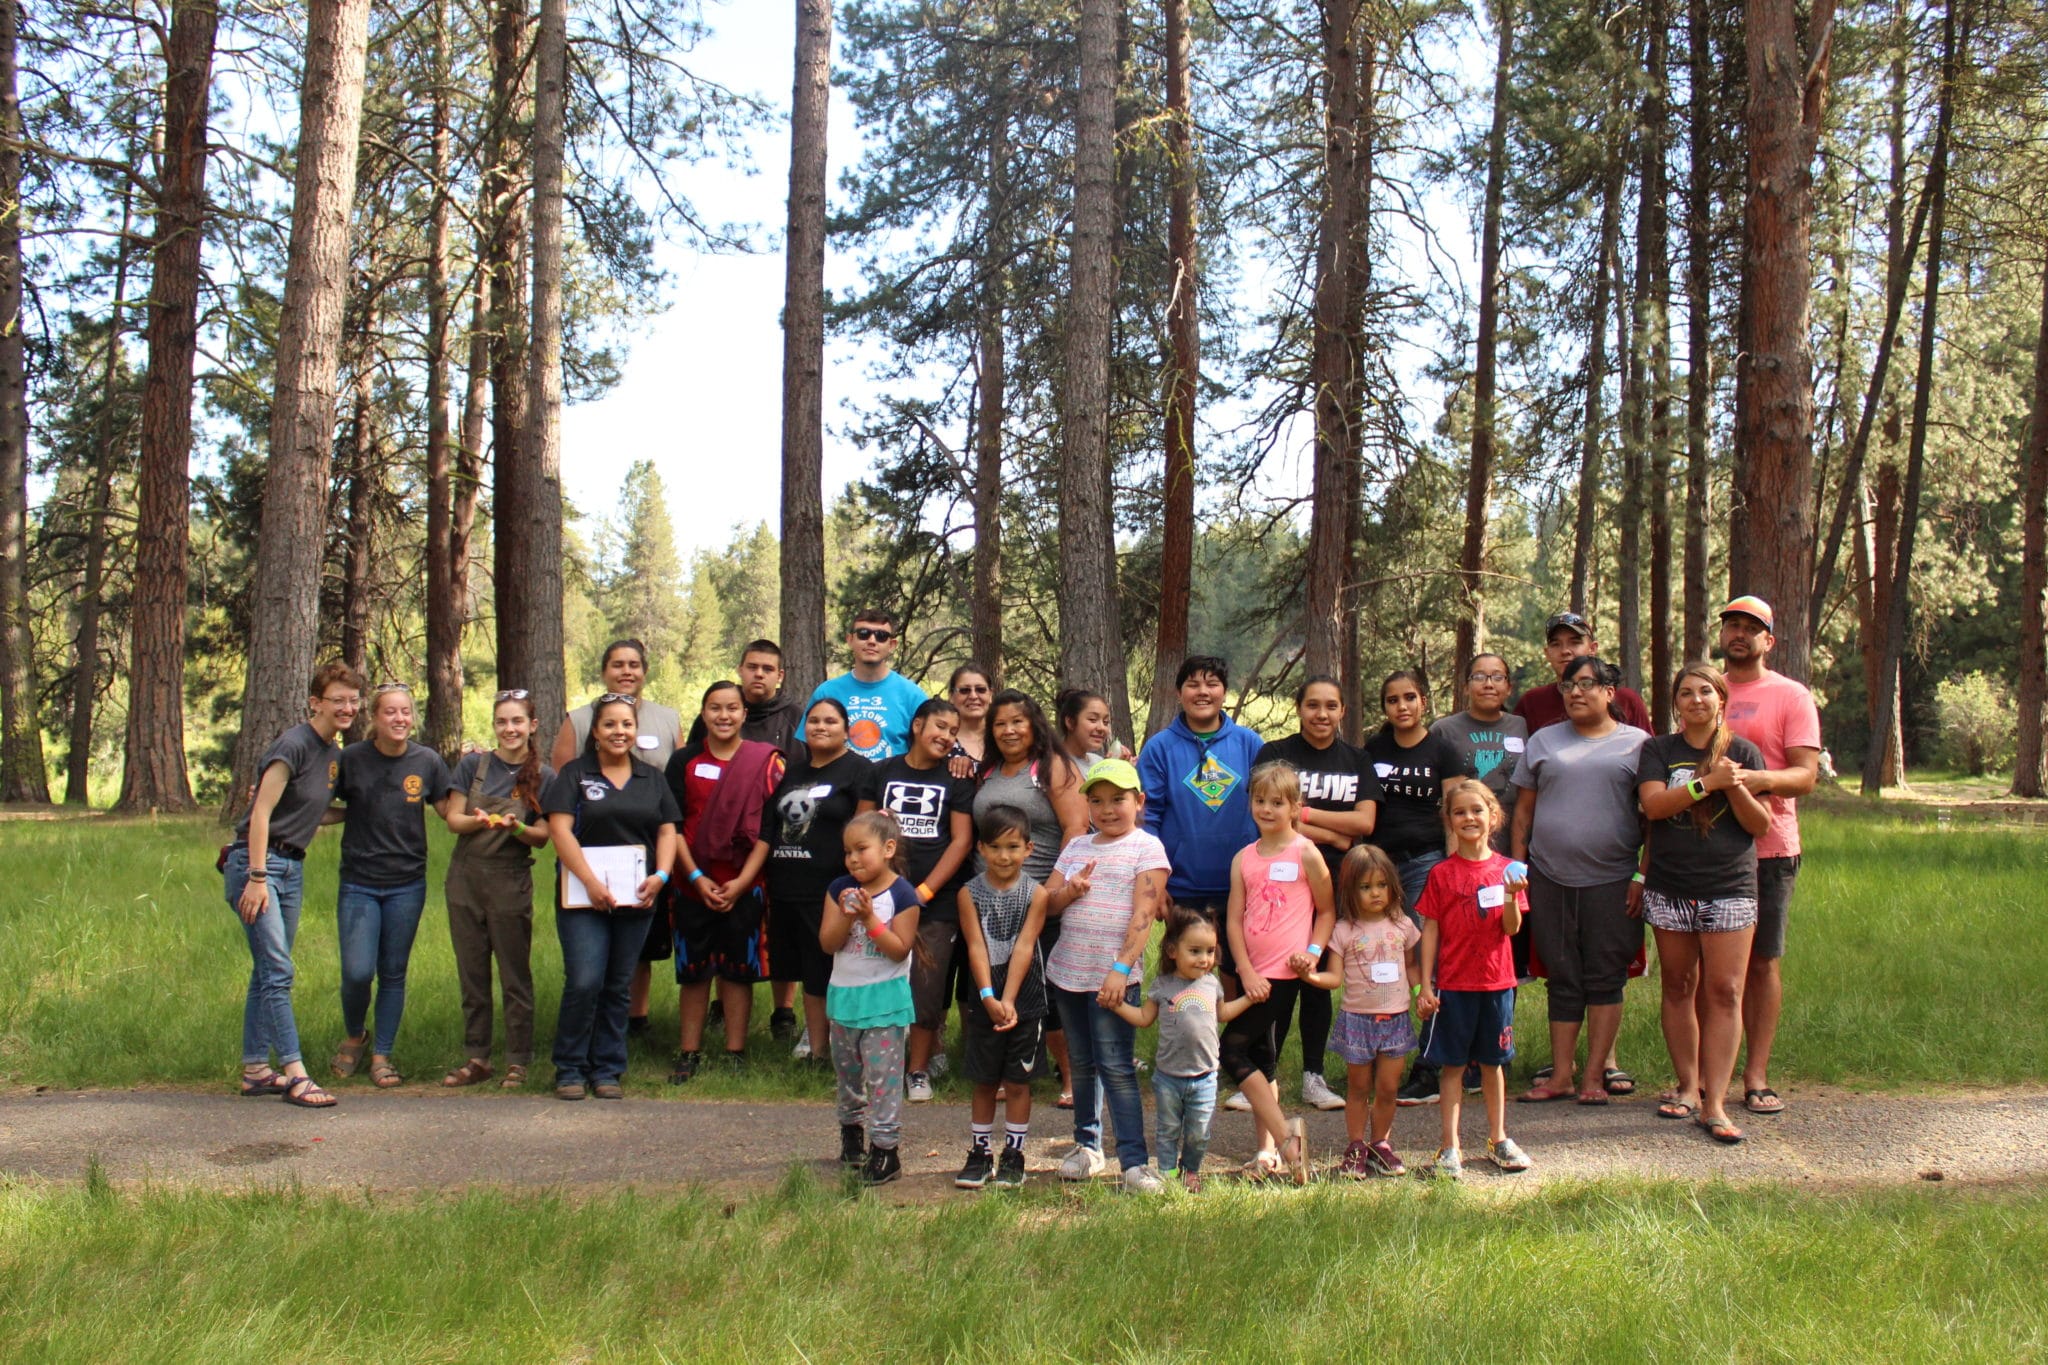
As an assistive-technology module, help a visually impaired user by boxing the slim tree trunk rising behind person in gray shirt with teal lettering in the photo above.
[1452,0,1516,684]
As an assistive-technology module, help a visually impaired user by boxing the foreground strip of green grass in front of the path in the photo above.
[0,1173,2048,1365]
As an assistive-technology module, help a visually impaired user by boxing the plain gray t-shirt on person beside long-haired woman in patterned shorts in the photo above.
[1513,722,1649,886]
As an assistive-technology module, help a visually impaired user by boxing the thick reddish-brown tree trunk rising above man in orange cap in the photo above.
[1729,0,1835,681]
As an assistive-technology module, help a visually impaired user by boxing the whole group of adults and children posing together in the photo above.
[221,598,1821,1191]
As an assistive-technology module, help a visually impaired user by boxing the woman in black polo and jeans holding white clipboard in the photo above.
[541,692,682,1099]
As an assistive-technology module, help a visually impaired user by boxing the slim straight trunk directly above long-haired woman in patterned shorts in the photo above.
[1683,0,1714,659]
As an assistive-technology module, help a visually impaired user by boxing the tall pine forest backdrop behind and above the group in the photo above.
[0,0,2048,810]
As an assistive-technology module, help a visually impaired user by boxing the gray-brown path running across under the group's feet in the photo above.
[0,1089,2048,1199]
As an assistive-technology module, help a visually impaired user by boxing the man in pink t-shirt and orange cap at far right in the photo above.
[1720,598,1821,1113]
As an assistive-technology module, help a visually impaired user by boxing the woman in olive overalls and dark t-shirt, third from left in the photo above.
[440,688,555,1091]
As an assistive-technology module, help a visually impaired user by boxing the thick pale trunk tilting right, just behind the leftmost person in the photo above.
[223,0,371,819]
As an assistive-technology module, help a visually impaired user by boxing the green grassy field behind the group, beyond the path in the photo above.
[0,802,2048,1099]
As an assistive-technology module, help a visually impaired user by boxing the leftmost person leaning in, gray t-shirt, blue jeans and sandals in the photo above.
[221,663,362,1109]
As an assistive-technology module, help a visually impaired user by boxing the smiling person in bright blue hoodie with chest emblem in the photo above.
[1139,655,1266,997]
